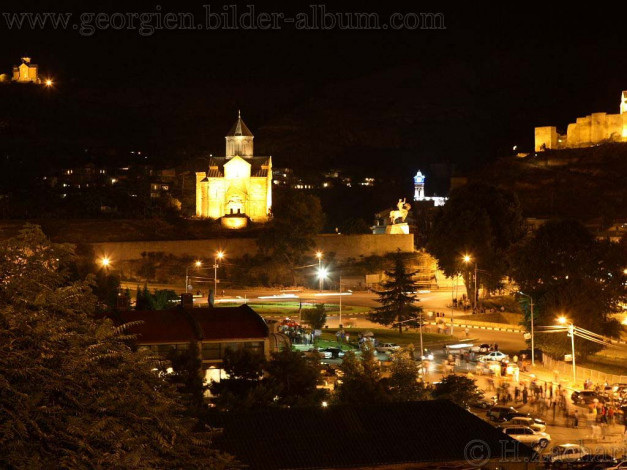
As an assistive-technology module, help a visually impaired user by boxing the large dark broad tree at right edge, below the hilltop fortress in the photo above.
[511,221,627,357]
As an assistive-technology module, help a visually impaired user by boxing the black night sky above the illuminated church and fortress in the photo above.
[0,2,627,175]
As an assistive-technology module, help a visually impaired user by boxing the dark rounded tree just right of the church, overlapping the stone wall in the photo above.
[257,190,324,284]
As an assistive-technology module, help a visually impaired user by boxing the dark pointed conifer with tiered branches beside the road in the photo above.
[369,253,422,333]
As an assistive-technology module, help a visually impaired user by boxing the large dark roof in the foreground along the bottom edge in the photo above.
[211,400,540,470]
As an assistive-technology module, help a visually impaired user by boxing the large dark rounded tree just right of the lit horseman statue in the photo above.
[427,183,525,298]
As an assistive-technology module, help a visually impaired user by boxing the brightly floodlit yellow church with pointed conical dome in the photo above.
[196,112,272,228]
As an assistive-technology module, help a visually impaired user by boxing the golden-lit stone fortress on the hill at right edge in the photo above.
[535,90,627,152]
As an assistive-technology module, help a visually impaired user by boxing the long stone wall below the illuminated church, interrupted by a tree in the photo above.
[91,234,414,261]
